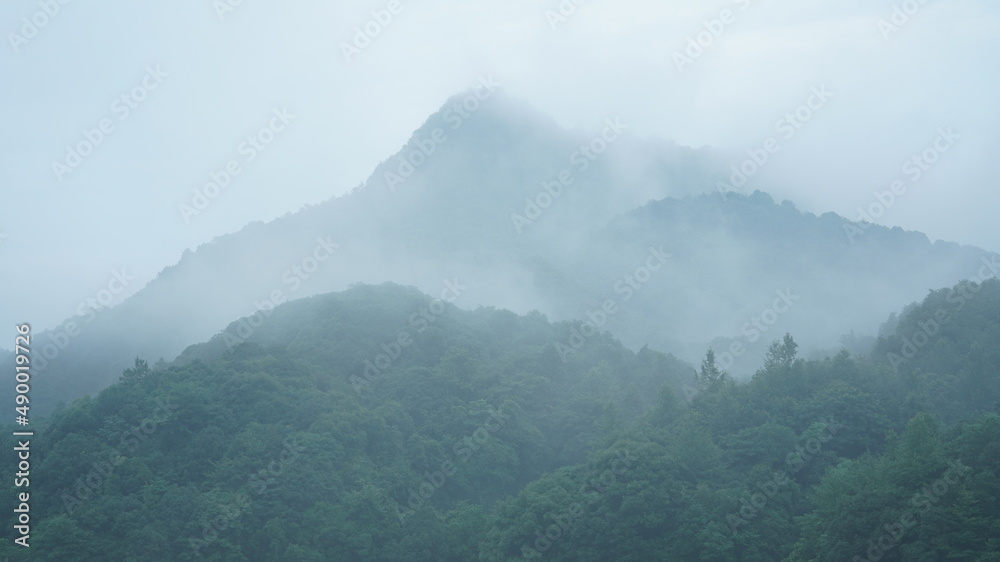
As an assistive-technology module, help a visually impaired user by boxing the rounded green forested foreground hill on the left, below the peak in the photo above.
[0,284,691,561]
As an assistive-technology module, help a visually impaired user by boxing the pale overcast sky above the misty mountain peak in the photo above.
[0,0,1000,330]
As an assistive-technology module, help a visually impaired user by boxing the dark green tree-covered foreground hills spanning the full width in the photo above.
[0,280,1000,562]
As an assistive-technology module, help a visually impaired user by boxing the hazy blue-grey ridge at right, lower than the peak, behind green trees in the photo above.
[536,191,1000,366]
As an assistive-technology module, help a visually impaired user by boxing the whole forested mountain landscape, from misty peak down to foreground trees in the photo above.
[0,81,1000,562]
